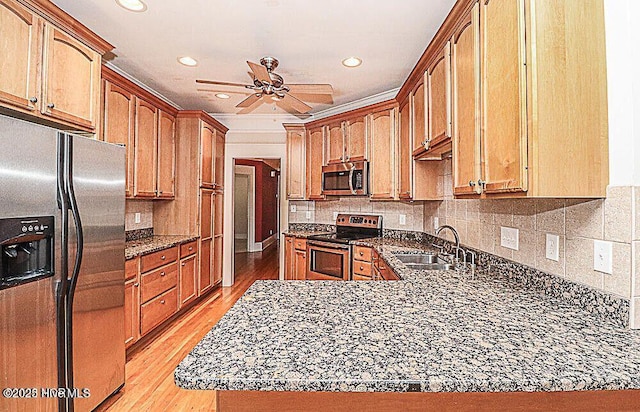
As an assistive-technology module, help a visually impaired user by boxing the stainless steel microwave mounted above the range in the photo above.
[322,161,369,196]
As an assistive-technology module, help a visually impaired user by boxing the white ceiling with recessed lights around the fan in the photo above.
[53,0,455,114]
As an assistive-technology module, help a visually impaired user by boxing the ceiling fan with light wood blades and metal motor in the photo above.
[196,57,333,114]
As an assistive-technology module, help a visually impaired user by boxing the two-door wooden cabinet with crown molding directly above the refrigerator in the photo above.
[0,0,113,133]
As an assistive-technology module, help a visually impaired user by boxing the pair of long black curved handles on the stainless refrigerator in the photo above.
[64,135,84,411]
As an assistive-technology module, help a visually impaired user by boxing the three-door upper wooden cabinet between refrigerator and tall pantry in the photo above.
[101,67,177,199]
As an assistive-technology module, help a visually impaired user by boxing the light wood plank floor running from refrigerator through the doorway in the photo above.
[98,245,278,412]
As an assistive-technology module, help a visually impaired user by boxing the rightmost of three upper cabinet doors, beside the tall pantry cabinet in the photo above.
[158,110,176,199]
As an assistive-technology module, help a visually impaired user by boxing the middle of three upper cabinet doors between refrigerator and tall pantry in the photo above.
[133,97,158,197]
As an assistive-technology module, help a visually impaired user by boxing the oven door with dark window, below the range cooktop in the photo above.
[307,241,351,280]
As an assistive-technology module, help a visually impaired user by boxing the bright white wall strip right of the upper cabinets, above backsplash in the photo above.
[604,0,640,186]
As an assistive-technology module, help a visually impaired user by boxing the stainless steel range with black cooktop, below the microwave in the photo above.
[307,214,382,280]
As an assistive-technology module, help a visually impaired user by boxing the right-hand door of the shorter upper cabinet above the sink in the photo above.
[426,42,451,149]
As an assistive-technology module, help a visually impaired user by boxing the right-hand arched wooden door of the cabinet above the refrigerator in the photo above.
[42,24,101,130]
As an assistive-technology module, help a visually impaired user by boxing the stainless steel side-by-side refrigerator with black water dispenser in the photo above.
[0,115,125,411]
